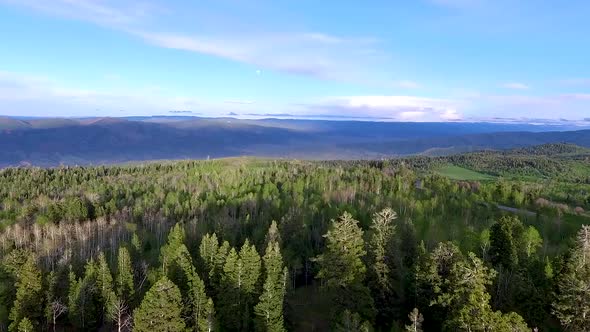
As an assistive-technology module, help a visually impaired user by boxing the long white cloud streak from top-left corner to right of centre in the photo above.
[5,0,382,81]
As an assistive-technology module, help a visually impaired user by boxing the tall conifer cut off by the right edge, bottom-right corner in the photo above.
[553,225,590,331]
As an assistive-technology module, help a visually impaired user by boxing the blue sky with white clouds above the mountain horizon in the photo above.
[0,0,590,123]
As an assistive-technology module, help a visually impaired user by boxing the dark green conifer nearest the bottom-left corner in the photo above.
[9,254,43,331]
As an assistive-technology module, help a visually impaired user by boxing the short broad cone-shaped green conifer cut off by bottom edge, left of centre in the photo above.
[133,277,185,332]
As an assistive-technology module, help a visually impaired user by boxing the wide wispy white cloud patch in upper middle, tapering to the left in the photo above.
[137,32,376,79]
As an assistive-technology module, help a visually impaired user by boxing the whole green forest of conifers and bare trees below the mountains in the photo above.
[0,144,590,332]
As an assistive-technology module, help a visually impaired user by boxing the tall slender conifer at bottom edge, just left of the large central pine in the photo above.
[254,242,287,332]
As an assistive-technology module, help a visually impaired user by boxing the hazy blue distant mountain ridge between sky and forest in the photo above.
[0,116,590,167]
